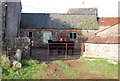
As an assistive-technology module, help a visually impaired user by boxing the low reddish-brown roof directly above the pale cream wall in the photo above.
[87,36,120,44]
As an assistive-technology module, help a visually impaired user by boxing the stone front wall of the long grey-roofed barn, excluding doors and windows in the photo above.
[20,29,88,47]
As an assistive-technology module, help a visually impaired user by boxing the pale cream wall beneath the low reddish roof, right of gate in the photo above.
[83,43,120,60]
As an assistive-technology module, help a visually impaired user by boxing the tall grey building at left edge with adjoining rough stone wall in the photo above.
[0,1,30,58]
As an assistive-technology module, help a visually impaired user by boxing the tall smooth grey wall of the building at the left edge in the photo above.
[5,2,22,38]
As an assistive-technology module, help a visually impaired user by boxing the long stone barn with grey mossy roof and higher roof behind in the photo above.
[20,8,98,46]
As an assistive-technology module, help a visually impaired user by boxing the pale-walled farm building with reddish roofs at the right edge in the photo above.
[83,18,120,59]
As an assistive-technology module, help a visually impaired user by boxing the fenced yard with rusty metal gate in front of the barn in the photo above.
[31,43,84,61]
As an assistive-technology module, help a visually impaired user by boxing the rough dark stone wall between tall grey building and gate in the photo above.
[5,37,30,58]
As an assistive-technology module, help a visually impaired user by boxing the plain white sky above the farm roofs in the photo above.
[21,0,120,17]
